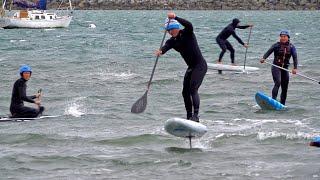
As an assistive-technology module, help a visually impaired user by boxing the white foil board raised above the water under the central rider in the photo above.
[164,118,207,138]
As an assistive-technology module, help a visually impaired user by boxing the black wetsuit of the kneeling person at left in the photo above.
[10,78,44,118]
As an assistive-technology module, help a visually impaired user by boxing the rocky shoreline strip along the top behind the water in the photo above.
[68,0,320,10]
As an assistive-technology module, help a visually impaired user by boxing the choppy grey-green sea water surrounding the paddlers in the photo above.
[0,11,320,180]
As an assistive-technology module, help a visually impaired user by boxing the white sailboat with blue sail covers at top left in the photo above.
[0,0,72,29]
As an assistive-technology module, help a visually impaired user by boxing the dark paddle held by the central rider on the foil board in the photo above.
[131,20,170,113]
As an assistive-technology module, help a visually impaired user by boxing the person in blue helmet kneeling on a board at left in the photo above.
[10,65,44,118]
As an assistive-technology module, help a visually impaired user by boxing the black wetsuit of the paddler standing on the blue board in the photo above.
[263,42,298,105]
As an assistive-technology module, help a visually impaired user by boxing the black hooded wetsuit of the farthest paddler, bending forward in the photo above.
[216,19,250,63]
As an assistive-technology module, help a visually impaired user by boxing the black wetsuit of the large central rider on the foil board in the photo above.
[161,17,207,119]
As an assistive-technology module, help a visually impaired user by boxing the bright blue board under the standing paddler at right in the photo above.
[255,92,285,110]
